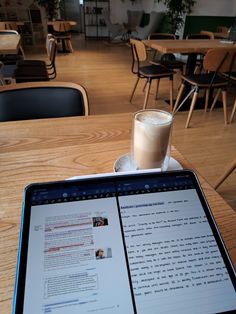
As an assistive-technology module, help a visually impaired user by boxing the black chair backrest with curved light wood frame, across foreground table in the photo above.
[0,82,89,122]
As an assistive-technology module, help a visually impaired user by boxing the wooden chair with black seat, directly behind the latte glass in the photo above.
[130,39,174,109]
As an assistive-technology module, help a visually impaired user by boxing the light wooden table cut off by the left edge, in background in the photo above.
[0,34,21,54]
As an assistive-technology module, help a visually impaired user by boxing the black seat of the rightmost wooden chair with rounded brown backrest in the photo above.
[182,73,228,87]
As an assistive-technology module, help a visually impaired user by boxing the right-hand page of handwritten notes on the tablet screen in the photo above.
[119,189,236,314]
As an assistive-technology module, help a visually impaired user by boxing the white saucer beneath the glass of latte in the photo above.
[113,154,183,172]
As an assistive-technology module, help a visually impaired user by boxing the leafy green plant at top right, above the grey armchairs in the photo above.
[157,0,196,34]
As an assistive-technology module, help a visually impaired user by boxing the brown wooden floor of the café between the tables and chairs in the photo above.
[26,35,236,210]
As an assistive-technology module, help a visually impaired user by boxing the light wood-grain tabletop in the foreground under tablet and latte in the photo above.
[0,114,236,314]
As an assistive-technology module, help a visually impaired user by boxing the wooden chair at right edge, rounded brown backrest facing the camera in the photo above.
[173,48,235,128]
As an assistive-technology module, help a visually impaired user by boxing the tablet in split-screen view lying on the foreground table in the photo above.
[13,170,236,314]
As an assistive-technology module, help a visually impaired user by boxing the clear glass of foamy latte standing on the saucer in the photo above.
[131,109,173,171]
